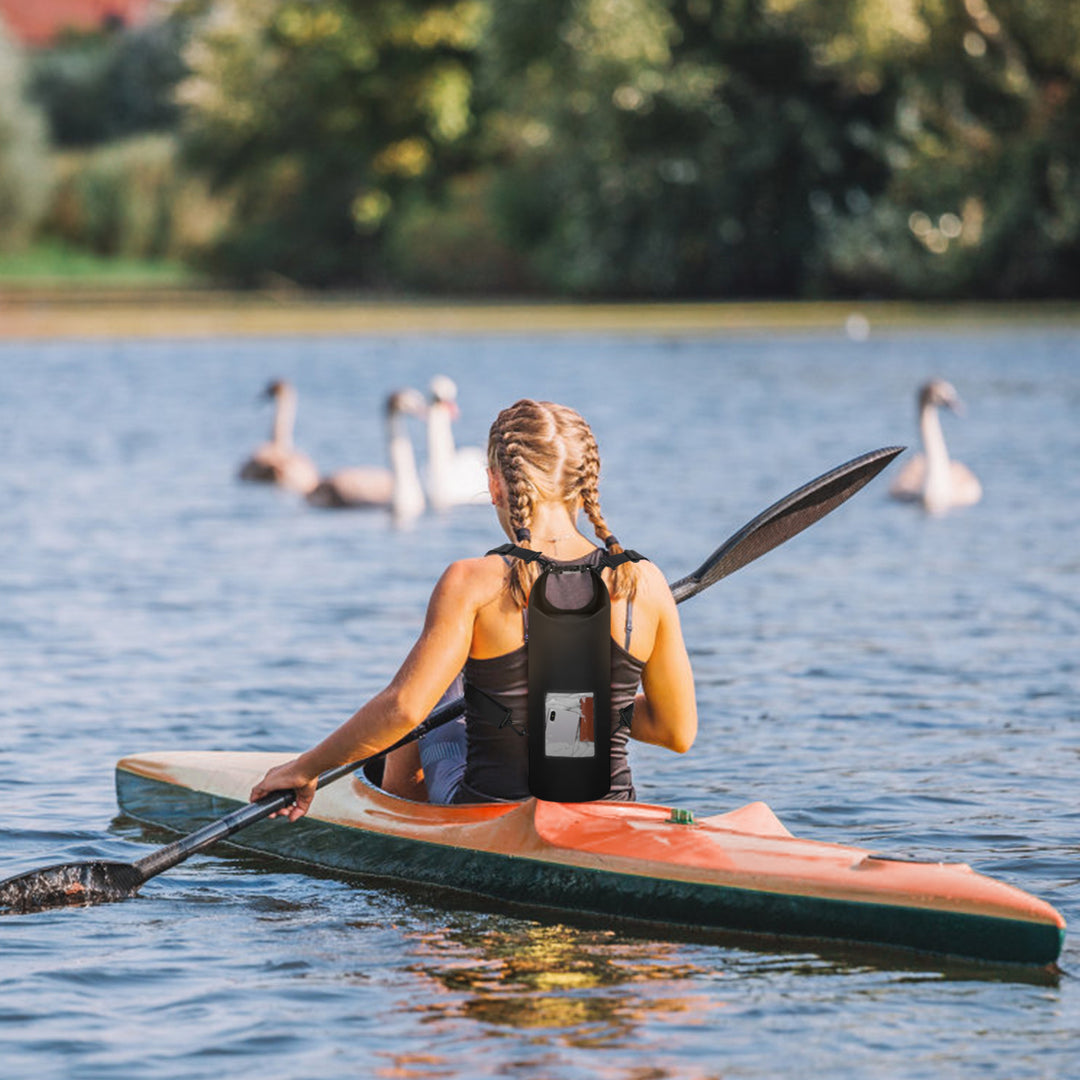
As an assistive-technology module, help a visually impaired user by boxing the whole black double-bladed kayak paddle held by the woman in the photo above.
[0,446,904,913]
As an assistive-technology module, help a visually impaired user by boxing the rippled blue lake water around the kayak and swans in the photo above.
[0,326,1080,1080]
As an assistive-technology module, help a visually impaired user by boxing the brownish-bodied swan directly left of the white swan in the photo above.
[308,388,428,521]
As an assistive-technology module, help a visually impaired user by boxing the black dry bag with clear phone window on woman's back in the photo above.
[489,544,643,802]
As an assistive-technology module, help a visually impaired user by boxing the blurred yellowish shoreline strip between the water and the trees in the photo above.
[0,285,1080,342]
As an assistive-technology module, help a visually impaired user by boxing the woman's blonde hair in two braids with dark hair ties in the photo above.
[487,397,637,607]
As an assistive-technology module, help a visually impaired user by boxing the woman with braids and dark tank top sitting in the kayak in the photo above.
[251,400,698,821]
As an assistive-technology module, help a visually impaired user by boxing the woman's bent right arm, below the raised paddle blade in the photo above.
[631,563,698,754]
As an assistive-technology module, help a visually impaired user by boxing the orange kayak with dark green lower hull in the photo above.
[116,751,1065,966]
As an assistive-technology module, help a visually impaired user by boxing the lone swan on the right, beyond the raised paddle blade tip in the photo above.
[889,379,983,514]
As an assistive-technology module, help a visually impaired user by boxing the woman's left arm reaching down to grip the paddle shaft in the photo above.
[251,559,477,821]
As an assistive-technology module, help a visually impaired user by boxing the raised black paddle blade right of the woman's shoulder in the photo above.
[672,446,907,602]
